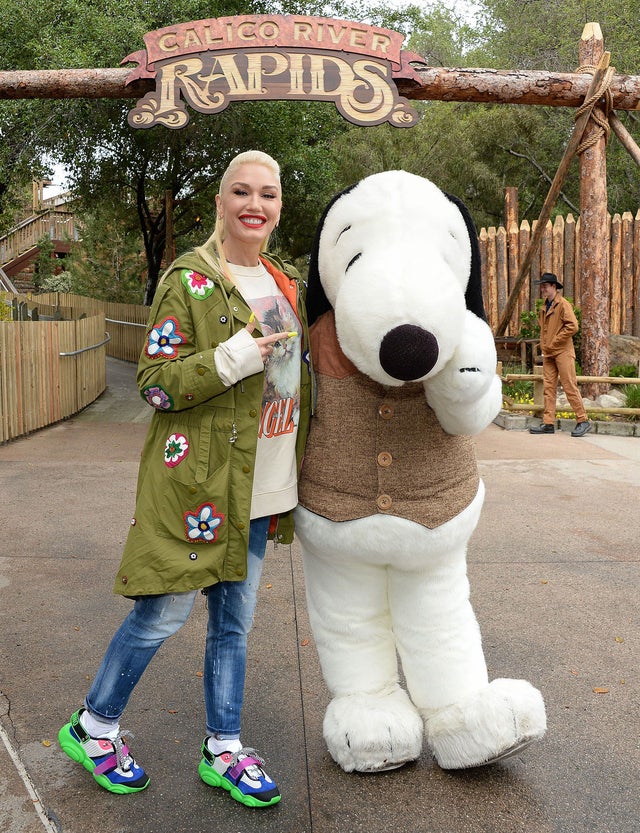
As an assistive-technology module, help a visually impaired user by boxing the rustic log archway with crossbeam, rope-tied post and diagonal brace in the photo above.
[0,17,640,386]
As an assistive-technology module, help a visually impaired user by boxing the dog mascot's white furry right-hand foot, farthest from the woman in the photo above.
[425,679,547,769]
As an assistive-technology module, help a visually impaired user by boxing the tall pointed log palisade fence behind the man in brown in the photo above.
[479,210,640,337]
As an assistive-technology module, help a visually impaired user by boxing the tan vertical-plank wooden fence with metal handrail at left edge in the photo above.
[0,315,107,442]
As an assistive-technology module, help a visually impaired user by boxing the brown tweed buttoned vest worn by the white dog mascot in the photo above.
[298,311,479,529]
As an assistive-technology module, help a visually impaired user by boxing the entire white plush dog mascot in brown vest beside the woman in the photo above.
[296,171,546,772]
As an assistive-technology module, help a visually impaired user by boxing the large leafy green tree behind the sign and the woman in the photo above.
[0,0,356,303]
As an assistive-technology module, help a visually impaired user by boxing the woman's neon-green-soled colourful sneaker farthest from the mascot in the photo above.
[58,708,149,795]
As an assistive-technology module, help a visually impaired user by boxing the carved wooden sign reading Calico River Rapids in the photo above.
[122,15,424,129]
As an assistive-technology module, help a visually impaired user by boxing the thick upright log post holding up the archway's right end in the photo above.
[578,23,609,399]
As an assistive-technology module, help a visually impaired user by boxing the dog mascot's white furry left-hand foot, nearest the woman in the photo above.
[323,689,423,772]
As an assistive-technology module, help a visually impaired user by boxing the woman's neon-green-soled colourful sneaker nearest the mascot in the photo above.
[198,738,282,807]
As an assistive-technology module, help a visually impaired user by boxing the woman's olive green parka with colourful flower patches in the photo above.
[114,252,312,597]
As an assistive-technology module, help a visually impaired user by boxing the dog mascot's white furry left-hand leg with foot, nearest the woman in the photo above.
[296,507,423,772]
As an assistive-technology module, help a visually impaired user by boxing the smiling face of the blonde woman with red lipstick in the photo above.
[216,162,282,255]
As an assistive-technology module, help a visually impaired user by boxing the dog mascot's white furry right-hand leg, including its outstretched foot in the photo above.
[389,494,546,769]
